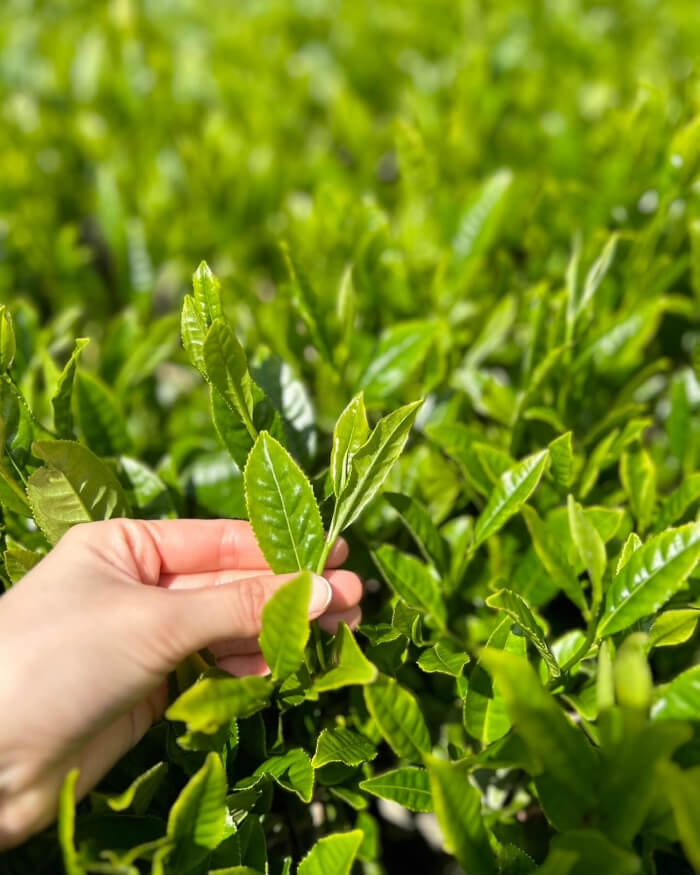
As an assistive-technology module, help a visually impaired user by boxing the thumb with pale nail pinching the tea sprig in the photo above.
[159,574,333,659]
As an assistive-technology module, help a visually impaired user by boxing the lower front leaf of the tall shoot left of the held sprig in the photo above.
[202,319,257,438]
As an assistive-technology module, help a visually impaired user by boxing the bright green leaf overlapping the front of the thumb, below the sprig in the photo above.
[260,572,312,680]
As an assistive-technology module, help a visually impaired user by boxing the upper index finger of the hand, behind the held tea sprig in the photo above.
[141,519,348,574]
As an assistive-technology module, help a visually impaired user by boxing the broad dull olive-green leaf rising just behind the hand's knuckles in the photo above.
[27,441,130,544]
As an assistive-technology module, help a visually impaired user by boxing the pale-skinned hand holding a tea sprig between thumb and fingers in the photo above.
[0,520,362,849]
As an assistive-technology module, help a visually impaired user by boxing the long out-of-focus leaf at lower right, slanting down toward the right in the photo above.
[481,648,597,830]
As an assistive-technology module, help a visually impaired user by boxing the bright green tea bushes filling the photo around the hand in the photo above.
[0,0,700,875]
